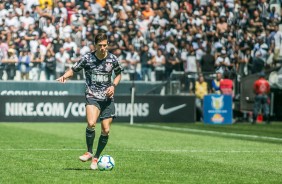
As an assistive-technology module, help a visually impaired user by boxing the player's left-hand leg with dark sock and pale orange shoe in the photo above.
[79,105,100,162]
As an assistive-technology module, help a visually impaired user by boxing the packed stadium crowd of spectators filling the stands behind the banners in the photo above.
[0,0,282,91]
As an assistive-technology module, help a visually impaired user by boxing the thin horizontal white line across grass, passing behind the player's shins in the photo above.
[0,148,282,153]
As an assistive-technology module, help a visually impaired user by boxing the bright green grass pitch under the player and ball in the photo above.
[0,123,282,184]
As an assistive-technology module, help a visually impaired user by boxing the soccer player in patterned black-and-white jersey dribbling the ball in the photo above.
[57,33,122,170]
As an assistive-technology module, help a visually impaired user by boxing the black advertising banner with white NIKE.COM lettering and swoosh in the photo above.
[0,95,196,123]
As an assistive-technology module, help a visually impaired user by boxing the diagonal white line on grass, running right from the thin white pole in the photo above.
[134,123,282,141]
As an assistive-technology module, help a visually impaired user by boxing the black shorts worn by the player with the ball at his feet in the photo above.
[86,98,116,120]
